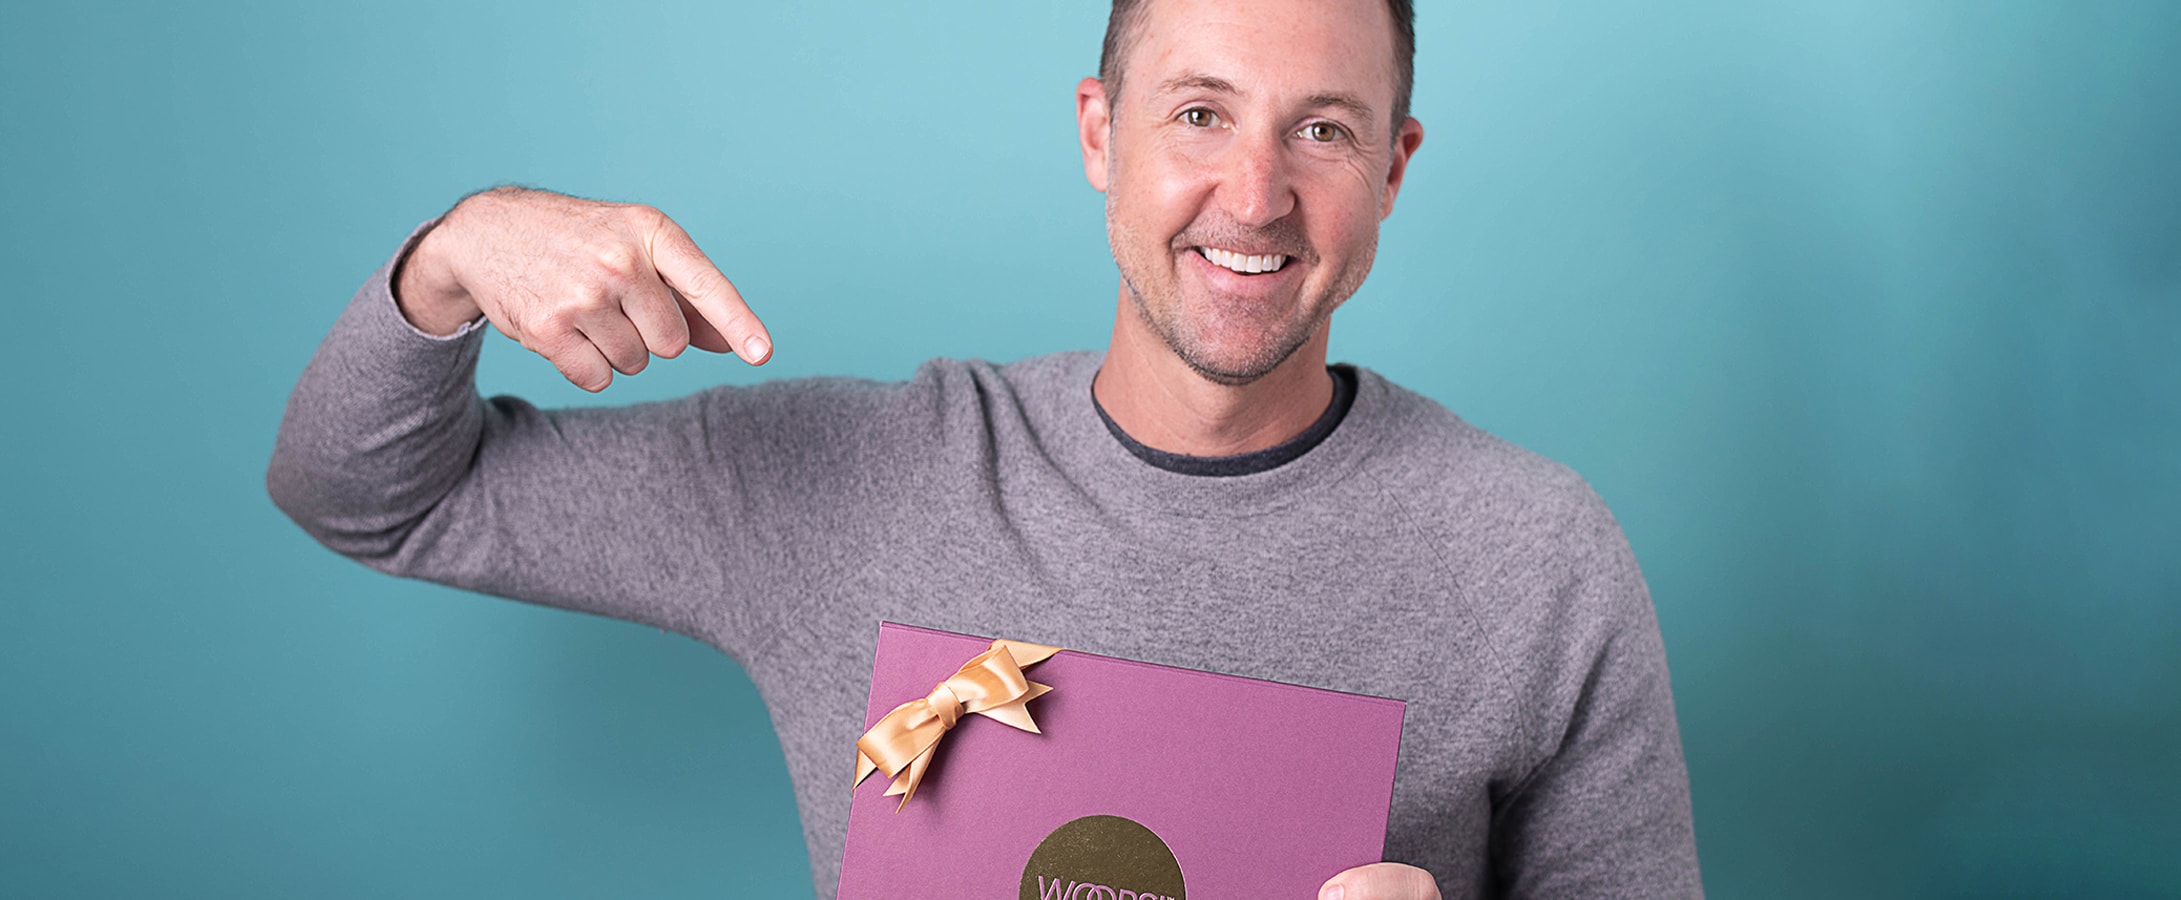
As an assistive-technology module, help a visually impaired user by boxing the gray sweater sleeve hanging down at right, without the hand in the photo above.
[1492,486,1703,898]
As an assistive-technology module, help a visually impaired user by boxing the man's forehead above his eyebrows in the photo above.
[1123,0,1394,113]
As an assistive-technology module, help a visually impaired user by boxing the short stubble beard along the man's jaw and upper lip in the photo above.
[1106,192,1378,388]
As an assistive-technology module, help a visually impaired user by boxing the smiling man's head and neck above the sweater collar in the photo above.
[1075,0,1424,455]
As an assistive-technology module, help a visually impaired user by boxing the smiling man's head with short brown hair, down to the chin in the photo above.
[1077,0,1422,384]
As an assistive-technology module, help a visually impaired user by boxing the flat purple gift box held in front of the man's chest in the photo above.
[840,623,1402,900]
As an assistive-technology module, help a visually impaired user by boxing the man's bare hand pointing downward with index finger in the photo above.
[395,187,772,392]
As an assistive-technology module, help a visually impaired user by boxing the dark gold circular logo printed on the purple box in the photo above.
[1021,815,1186,900]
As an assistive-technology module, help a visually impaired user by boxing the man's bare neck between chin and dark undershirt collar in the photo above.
[1091,288,1333,455]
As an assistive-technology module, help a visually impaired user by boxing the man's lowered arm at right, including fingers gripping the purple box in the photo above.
[1317,483,1703,900]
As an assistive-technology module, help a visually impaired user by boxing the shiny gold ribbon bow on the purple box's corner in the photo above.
[855,641,1060,811]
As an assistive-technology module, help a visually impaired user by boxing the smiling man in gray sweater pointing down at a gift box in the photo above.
[268,0,1701,900]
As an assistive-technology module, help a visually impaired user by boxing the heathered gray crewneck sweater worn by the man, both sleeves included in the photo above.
[266,229,1701,898]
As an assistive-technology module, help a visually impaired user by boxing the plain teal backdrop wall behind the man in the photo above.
[0,0,2181,898]
